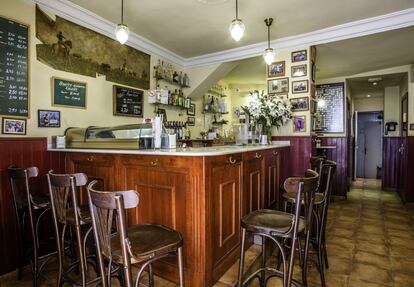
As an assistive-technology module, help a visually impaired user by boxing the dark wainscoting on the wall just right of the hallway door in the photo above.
[382,137,400,189]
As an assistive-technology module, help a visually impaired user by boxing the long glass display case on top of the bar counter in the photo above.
[65,123,153,149]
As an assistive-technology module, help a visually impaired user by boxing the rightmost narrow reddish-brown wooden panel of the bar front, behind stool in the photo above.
[264,149,280,209]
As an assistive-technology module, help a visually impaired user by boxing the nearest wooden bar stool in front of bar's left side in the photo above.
[87,181,184,287]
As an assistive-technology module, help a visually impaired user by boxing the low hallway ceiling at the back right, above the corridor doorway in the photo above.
[347,73,408,98]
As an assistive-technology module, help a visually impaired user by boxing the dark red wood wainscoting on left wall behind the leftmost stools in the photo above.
[0,137,65,274]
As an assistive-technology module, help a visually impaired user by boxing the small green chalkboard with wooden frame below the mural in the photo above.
[52,77,87,109]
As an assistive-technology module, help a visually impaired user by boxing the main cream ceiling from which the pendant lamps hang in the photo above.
[71,0,414,58]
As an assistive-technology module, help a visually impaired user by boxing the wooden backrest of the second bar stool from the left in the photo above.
[46,171,88,225]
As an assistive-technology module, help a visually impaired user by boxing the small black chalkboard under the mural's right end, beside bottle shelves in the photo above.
[113,85,144,117]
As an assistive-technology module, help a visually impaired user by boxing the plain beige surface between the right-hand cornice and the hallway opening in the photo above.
[317,27,414,79]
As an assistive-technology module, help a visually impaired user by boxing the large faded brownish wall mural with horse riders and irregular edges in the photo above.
[36,7,150,89]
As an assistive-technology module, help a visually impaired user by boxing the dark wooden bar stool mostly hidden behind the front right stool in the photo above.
[282,160,336,287]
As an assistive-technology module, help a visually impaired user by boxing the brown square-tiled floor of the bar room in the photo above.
[0,180,414,287]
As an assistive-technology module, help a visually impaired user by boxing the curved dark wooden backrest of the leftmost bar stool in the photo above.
[8,166,39,209]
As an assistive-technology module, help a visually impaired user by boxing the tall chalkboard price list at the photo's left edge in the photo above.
[0,17,29,118]
